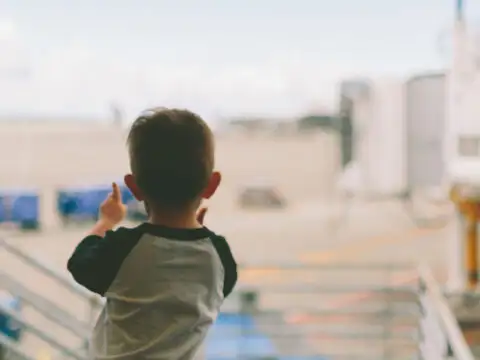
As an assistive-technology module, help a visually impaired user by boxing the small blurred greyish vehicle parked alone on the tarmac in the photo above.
[239,183,286,209]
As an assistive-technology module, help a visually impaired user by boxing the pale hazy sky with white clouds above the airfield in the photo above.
[0,0,480,121]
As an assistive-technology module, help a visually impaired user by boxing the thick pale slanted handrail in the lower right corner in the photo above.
[418,265,475,360]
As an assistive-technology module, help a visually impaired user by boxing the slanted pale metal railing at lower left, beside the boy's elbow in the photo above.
[0,240,100,360]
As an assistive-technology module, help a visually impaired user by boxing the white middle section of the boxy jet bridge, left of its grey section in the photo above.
[341,79,406,197]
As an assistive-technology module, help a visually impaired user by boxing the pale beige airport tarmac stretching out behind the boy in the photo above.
[0,129,452,360]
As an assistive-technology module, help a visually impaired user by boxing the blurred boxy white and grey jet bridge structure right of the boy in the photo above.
[339,73,447,196]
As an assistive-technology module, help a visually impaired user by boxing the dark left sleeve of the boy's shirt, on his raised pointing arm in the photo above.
[67,228,141,296]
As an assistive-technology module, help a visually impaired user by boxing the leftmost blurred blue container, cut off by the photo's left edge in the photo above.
[0,189,40,228]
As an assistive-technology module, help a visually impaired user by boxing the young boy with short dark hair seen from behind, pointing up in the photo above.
[68,108,237,360]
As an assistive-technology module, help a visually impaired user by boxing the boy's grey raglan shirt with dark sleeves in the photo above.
[67,223,237,360]
